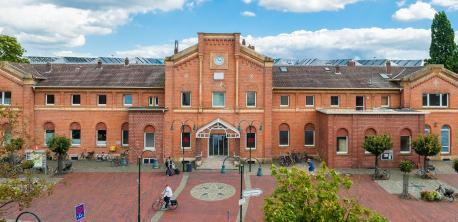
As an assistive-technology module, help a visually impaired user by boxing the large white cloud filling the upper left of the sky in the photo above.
[0,0,204,50]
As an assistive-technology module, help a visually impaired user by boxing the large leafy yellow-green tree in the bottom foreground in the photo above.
[264,164,387,222]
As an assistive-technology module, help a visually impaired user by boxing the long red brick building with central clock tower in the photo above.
[0,33,458,167]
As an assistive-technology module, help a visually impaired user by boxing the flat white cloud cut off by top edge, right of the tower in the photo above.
[252,0,361,12]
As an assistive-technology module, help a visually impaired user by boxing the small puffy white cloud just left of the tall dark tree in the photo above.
[393,1,436,21]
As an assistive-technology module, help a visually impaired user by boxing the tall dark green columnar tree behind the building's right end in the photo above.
[428,11,457,71]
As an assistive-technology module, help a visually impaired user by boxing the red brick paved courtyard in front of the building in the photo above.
[8,160,458,222]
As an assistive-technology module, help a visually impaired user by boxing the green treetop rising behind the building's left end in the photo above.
[0,35,29,63]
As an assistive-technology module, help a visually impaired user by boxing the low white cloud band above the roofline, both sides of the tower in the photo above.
[115,27,436,59]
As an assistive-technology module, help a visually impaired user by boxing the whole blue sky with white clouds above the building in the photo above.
[0,0,458,59]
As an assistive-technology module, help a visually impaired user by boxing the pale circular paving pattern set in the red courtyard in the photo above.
[191,183,235,201]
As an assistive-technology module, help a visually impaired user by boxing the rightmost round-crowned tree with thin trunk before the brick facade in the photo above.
[412,134,441,177]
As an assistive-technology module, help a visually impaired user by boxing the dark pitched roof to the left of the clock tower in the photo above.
[28,64,164,88]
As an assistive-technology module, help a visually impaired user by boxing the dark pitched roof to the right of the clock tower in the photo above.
[272,66,423,89]
